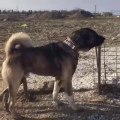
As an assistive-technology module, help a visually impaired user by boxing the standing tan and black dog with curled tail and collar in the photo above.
[2,28,105,114]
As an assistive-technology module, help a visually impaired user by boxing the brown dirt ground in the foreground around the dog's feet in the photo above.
[0,89,120,120]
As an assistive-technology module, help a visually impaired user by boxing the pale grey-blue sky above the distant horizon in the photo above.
[0,0,120,12]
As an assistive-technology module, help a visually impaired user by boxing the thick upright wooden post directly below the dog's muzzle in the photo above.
[96,46,101,94]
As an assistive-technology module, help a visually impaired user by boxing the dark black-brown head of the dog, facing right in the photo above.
[70,28,105,51]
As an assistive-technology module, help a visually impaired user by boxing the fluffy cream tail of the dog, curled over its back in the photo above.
[5,32,32,56]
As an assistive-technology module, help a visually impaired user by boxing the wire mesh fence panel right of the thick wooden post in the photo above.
[101,41,120,84]
